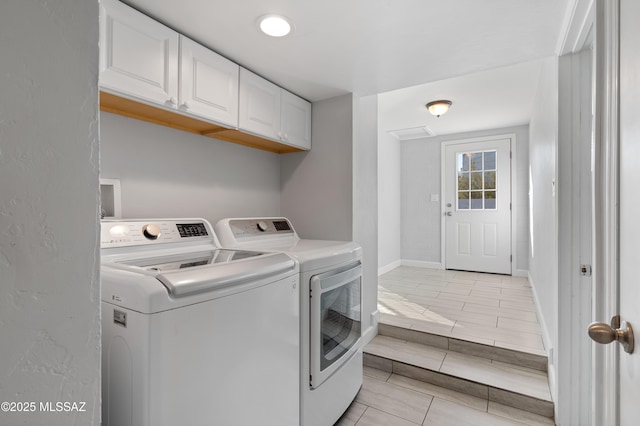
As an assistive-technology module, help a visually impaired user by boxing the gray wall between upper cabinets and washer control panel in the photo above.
[100,112,280,224]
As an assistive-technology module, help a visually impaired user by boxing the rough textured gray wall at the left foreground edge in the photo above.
[0,0,101,425]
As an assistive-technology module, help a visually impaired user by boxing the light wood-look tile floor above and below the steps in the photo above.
[336,266,554,426]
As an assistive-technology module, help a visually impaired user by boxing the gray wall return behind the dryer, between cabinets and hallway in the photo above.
[281,94,378,338]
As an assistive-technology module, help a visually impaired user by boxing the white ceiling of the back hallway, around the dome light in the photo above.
[378,60,543,139]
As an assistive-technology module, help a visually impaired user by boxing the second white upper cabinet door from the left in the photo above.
[179,35,240,128]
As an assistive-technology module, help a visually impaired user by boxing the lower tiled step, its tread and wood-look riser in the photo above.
[364,330,554,418]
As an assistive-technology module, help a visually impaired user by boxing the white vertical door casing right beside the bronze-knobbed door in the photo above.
[592,0,620,426]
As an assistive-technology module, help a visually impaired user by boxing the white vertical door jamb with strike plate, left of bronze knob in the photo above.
[550,17,595,425]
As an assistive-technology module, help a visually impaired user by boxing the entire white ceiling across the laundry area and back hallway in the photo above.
[125,0,575,134]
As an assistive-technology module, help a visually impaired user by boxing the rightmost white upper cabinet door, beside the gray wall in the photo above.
[282,90,311,150]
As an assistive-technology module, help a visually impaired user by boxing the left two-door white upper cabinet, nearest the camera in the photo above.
[100,0,240,128]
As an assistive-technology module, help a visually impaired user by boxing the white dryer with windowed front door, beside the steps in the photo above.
[215,217,362,426]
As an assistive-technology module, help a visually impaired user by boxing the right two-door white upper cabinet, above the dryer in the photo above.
[238,68,311,150]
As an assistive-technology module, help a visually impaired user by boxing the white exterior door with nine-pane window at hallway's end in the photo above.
[442,137,511,274]
